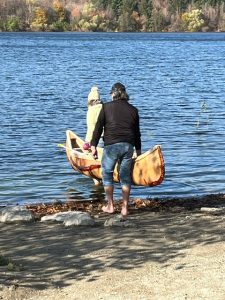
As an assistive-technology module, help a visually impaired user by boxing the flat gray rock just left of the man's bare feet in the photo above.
[41,211,95,226]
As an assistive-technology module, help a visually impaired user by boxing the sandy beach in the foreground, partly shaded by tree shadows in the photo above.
[0,195,225,300]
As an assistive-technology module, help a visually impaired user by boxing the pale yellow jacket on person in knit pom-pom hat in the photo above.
[85,103,102,143]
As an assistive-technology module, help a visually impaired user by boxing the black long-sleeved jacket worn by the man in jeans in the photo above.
[91,100,141,151]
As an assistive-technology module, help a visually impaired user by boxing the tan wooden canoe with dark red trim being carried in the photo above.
[65,130,165,186]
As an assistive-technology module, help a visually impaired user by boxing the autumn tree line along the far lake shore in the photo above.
[0,0,225,32]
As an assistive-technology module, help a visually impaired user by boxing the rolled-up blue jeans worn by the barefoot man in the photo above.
[102,143,134,186]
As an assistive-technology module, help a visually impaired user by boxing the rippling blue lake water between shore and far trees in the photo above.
[0,33,225,204]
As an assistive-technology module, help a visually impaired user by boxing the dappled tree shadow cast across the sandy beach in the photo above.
[0,196,225,290]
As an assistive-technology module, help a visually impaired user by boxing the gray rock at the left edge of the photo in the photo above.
[0,206,35,223]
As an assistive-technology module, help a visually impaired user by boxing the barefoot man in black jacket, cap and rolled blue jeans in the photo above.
[91,82,141,218]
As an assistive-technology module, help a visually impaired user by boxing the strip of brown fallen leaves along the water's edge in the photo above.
[0,193,225,219]
